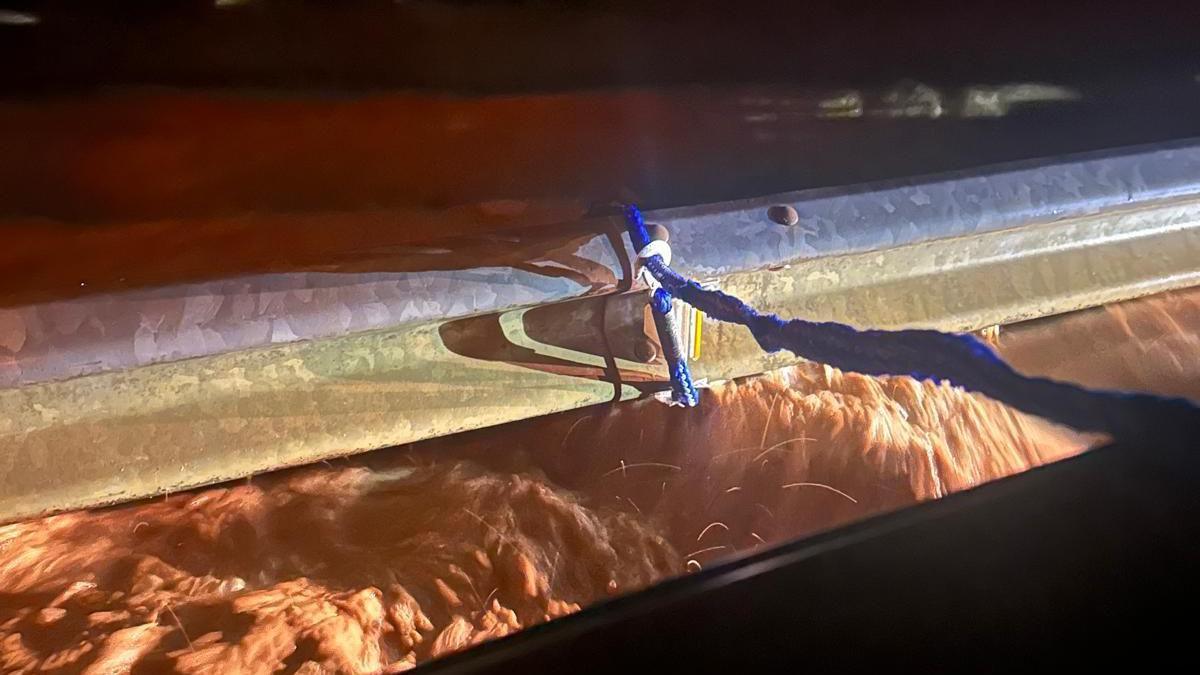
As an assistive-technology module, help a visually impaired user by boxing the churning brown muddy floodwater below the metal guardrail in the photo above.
[0,285,1200,673]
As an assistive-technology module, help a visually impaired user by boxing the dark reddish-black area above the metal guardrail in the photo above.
[7,0,1200,299]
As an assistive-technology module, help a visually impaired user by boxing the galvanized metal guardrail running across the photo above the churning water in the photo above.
[0,144,1200,519]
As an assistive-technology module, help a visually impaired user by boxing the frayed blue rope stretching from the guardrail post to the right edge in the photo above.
[625,205,1200,442]
